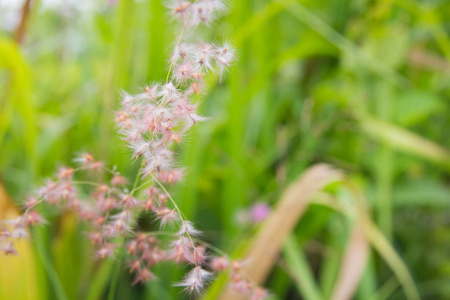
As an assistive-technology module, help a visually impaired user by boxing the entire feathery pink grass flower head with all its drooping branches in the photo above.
[0,0,267,300]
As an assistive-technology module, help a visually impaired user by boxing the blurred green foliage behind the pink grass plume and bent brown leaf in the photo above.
[0,0,450,300]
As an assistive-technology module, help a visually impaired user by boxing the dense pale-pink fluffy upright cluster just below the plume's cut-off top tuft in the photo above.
[116,42,234,183]
